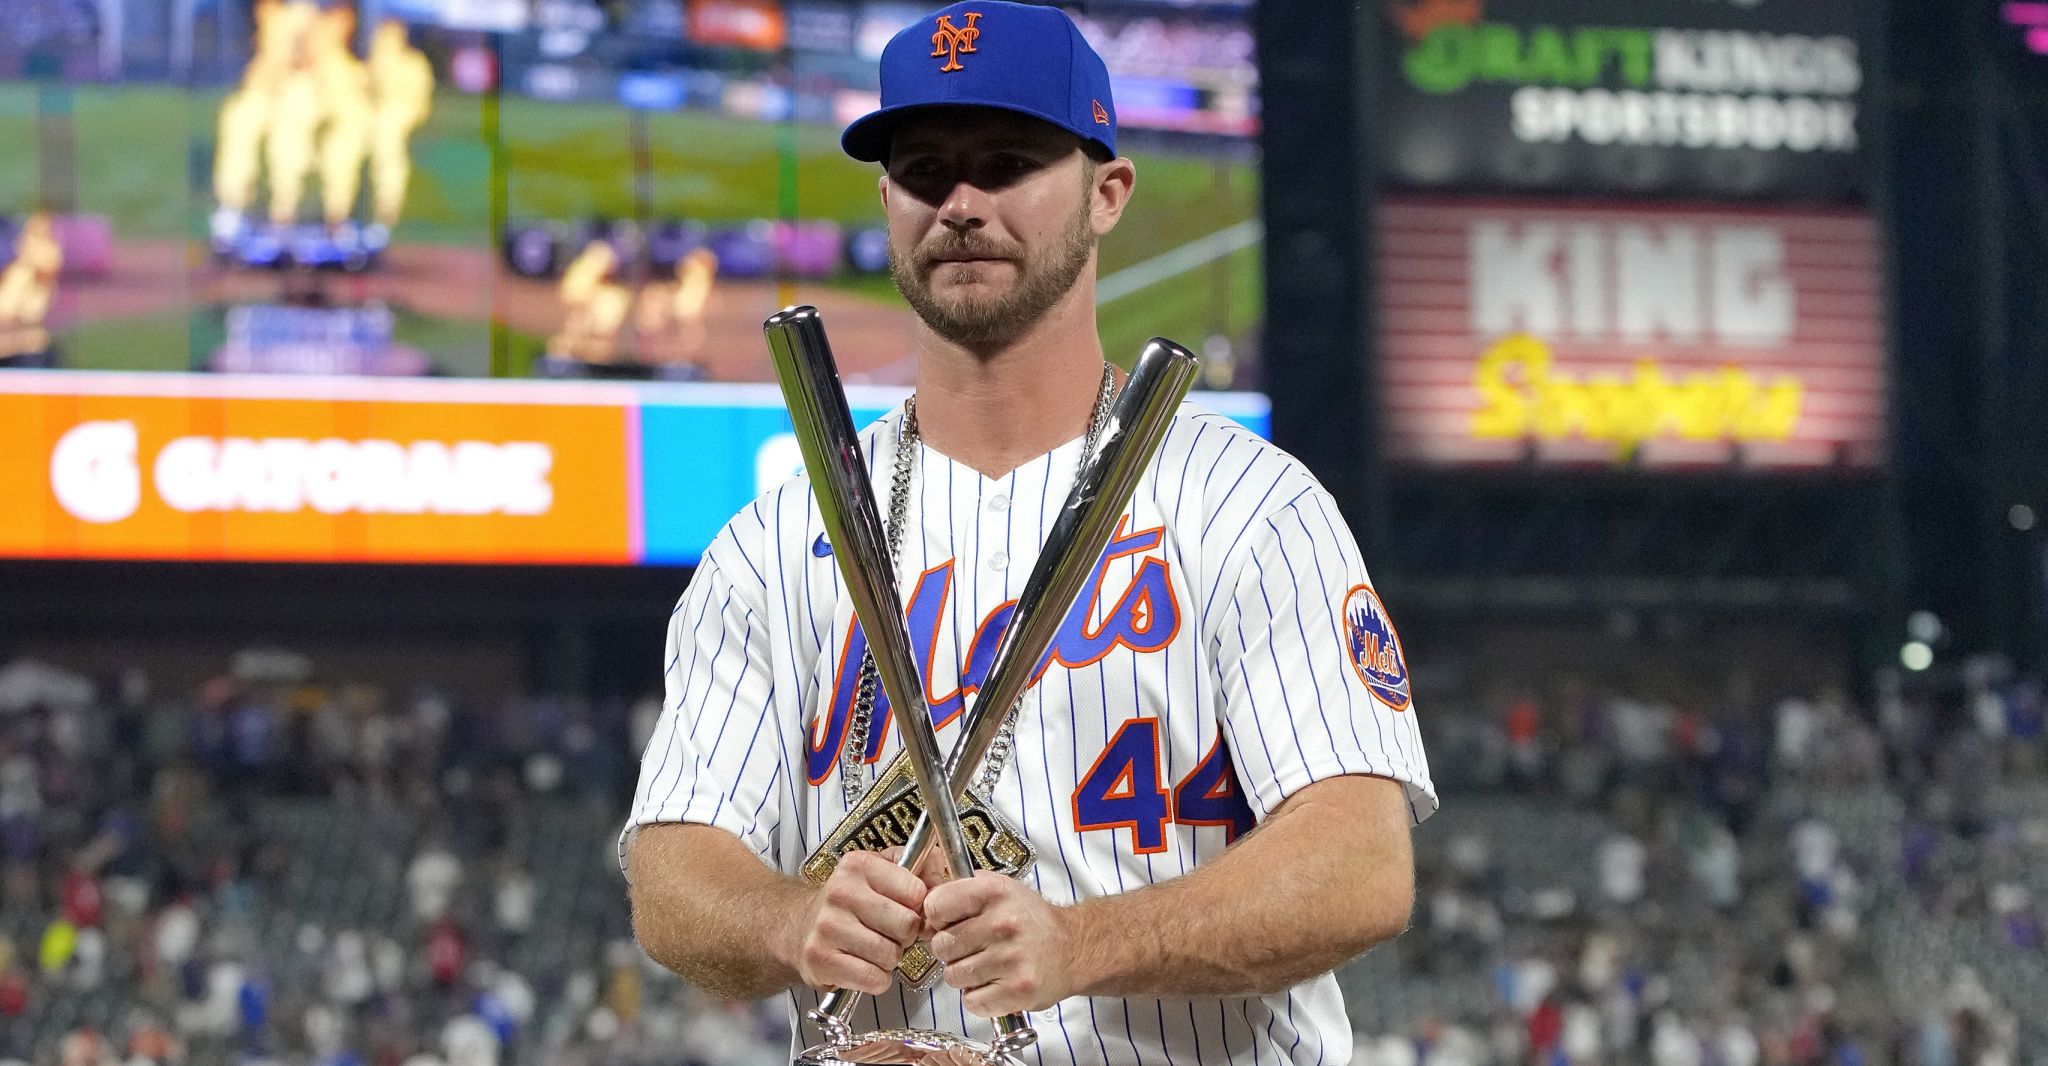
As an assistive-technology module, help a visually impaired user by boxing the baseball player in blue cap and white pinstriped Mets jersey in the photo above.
[621,0,1436,1066]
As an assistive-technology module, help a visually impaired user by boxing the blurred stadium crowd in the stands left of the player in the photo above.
[0,653,788,1066]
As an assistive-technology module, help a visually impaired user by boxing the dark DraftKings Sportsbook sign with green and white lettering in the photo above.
[1376,0,1870,201]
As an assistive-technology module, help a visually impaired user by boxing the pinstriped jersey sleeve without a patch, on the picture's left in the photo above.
[618,532,784,868]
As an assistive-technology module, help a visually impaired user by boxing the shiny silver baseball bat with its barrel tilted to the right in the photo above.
[811,338,1196,1043]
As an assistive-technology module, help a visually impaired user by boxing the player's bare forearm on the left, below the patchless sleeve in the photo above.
[629,825,813,998]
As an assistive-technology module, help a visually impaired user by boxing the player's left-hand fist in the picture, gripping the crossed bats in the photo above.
[795,851,926,996]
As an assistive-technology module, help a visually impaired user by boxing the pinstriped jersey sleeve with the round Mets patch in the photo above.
[1214,485,1438,823]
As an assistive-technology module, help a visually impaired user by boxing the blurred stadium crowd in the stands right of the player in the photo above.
[1392,659,2048,1066]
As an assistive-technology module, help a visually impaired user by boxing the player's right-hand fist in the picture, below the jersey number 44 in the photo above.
[924,870,1077,1017]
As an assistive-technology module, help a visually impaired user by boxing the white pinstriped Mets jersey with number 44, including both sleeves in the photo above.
[629,403,1436,1066]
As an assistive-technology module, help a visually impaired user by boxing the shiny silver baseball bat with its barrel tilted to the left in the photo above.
[762,307,1038,1050]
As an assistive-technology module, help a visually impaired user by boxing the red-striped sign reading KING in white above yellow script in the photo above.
[1376,196,1884,471]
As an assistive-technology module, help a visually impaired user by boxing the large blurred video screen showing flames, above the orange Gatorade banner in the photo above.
[0,0,1262,389]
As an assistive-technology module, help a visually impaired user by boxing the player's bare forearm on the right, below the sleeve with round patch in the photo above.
[1065,778,1415,996]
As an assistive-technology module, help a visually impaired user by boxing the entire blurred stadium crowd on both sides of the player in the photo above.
[0,653,2048,1066]
